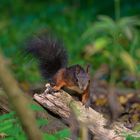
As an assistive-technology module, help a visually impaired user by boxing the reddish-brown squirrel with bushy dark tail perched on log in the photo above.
[26,34,90,107]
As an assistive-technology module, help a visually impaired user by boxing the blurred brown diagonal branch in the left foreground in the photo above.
[0,54,42,140]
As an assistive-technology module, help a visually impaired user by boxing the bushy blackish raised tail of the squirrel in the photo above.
[27,34,67,80]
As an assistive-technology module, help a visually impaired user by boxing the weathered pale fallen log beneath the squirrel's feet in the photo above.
[34,83,140,140]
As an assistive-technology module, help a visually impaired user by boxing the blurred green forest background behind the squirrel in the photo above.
[0,0,140,86]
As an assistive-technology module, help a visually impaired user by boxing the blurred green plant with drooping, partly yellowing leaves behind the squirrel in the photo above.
[82,16,140,85]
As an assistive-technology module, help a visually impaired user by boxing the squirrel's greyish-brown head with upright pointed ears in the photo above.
[76,65,90,90]
